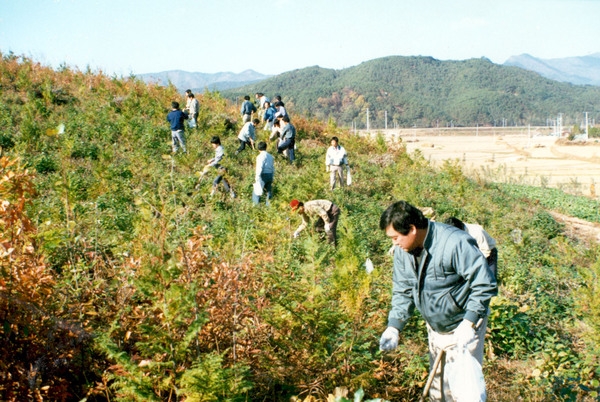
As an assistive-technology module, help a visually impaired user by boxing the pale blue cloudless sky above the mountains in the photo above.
[0,0,600,75]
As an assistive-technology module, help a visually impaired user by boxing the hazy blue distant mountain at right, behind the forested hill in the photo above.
[504,53,600,86]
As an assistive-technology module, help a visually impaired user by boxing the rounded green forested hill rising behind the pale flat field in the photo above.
[223,56,600,128]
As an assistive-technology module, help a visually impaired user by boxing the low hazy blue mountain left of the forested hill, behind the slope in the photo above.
[137,70,271,92]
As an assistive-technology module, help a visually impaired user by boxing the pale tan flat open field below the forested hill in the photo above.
[361,127,600,199]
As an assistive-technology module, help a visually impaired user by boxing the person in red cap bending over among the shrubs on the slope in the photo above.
[290,200,340,246]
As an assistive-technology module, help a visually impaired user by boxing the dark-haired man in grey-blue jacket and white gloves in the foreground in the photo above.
[379,201,498,401]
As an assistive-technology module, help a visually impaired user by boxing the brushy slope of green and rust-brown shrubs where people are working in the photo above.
[0,55,600,402]
